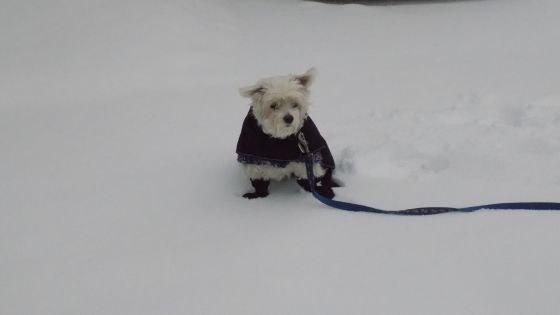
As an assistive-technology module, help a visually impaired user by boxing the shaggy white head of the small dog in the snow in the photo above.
[239,68,315,139]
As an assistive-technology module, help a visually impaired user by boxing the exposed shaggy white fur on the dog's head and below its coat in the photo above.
[239,68,325,180]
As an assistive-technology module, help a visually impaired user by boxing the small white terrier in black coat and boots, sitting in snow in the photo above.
[236,68,338,199]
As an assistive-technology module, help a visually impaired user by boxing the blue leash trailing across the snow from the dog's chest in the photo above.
[298,132,560,216]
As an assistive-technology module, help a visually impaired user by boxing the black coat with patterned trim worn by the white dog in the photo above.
[236,110,335,169]
